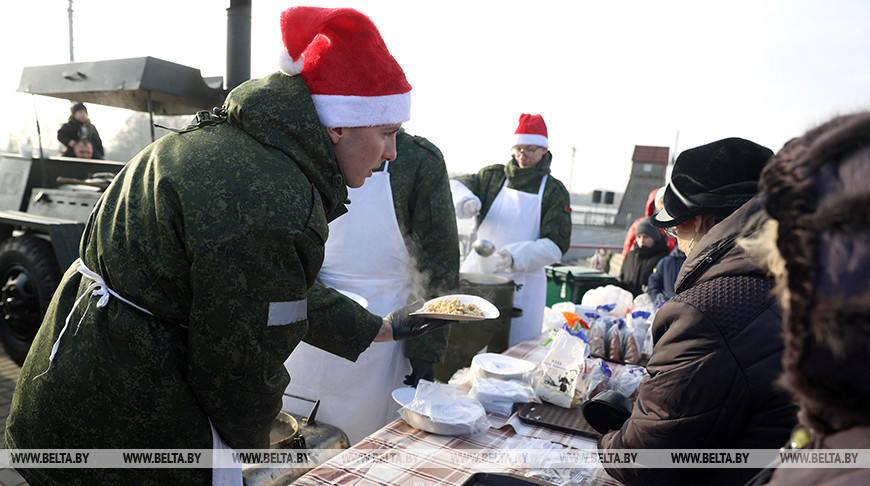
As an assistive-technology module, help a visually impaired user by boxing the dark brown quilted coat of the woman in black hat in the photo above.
[599,198,796,485]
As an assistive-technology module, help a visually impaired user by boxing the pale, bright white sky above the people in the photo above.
[0,0,870,192]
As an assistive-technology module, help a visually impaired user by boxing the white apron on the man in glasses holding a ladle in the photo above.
[459,176,547,346]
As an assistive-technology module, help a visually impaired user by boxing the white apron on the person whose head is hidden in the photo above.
[284,162,411,444]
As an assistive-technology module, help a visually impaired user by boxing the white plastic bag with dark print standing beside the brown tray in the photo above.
[532,326,589,408]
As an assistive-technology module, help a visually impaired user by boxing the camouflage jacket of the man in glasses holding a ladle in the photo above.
[455,151,571,255]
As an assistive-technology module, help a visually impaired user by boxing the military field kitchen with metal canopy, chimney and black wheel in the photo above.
[0,0,251,364]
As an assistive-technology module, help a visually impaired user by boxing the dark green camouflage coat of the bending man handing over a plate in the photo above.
[5,73,382,484]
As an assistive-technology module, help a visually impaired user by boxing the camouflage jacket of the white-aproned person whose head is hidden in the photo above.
[379,130,459,363]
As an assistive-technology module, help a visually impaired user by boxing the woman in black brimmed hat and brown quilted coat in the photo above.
[598,138,796,485]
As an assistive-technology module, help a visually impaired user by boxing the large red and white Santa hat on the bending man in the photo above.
[279,7,411,128]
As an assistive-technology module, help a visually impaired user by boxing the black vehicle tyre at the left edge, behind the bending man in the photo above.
[0,236,60,365]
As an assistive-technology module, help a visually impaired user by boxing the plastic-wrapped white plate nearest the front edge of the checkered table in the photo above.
[399,380,490,436]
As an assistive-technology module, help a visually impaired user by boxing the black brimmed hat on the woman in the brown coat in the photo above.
[651,138,773,228]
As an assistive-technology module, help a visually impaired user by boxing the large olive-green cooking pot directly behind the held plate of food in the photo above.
[435,273,521,383]
